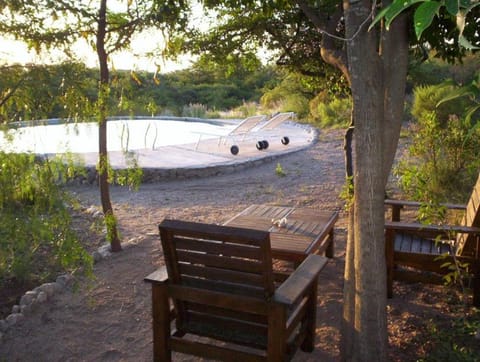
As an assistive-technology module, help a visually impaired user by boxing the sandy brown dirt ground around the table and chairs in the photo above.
[0,131,478,361]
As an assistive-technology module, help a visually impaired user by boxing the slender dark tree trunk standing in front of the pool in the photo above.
[96,0,122,251]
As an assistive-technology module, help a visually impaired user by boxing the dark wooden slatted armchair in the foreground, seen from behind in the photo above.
[145,219,327,361]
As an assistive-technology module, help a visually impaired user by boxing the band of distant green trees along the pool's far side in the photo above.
[0,63,279,122]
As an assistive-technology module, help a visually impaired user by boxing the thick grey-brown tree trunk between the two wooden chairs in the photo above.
[342,0,408,361]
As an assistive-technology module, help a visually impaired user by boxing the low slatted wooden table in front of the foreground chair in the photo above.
[225,205,338,265]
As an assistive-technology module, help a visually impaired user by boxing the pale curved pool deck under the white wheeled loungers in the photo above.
[77,122,318,182]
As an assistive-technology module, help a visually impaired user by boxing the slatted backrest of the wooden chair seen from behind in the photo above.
[159,219,275,298]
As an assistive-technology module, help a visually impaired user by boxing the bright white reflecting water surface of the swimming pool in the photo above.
[0,117,234,154]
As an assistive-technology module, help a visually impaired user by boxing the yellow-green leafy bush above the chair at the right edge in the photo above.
[395,82,480,203]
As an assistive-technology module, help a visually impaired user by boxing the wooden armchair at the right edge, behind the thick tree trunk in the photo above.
[385,175,480,306]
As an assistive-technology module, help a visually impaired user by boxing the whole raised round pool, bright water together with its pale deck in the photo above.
[0,117,318,184]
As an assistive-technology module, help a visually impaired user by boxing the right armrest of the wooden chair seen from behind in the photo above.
[273,254,328,306]
